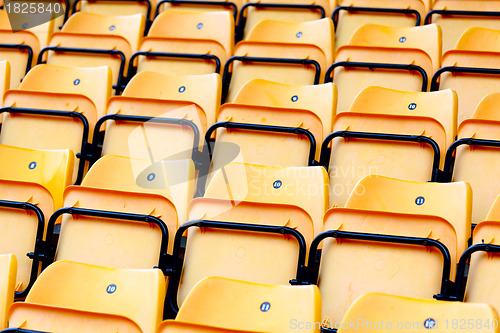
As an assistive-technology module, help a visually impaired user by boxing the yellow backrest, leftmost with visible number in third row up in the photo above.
[19,65,112,117]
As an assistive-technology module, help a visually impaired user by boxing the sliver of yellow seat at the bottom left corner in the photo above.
[0,254,17,329]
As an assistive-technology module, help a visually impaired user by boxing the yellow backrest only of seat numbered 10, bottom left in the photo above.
[20,261,165,332]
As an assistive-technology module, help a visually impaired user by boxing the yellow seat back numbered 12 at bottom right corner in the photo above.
[338,293,498,333]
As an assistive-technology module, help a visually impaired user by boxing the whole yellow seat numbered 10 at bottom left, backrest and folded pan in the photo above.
[5,261,165,332]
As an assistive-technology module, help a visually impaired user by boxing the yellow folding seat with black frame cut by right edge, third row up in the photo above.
[444,94,500,224]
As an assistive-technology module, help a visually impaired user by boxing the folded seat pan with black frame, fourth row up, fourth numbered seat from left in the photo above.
[325,45,433,113]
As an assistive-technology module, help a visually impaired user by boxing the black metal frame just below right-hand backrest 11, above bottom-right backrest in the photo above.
[307,230,452,299]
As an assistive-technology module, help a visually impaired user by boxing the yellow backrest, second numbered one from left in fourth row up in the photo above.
[148,10,234,58]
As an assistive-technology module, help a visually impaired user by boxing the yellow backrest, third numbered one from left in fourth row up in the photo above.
[245,18,335,66]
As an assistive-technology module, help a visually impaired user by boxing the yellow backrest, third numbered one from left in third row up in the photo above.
[233,79,337,142]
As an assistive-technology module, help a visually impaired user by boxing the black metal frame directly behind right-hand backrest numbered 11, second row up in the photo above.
[319,131,441,182]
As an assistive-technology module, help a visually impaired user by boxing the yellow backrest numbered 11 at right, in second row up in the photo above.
[346,176,472,253]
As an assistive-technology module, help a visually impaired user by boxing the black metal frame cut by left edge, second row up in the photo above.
[0,200,45,298]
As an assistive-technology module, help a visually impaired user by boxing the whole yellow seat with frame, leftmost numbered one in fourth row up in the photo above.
[38,12,145,93]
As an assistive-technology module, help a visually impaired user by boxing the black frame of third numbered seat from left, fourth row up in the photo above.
[221,56,321,104]
